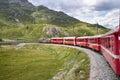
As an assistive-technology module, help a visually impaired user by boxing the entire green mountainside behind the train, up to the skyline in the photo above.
[0,0,109,41]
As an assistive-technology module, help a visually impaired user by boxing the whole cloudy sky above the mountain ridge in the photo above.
[29,0,120,28]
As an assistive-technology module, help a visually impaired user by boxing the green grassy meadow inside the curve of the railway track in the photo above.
[0,45,90,80]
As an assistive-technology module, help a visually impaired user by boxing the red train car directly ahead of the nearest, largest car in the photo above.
[88,35,101,52]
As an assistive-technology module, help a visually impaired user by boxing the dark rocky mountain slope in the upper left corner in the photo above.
[0,0,35,25]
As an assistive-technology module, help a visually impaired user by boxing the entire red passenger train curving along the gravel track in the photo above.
[50,27,120,75]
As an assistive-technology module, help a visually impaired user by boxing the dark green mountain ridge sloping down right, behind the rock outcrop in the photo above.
[32,6,80,26]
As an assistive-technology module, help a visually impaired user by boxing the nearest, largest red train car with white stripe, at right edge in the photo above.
[101,28,120,75]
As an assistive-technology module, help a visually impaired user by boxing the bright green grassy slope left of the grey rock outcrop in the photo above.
[0,24,44,41]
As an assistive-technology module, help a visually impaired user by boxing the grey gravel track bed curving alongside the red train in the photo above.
[51,45,120,80]
